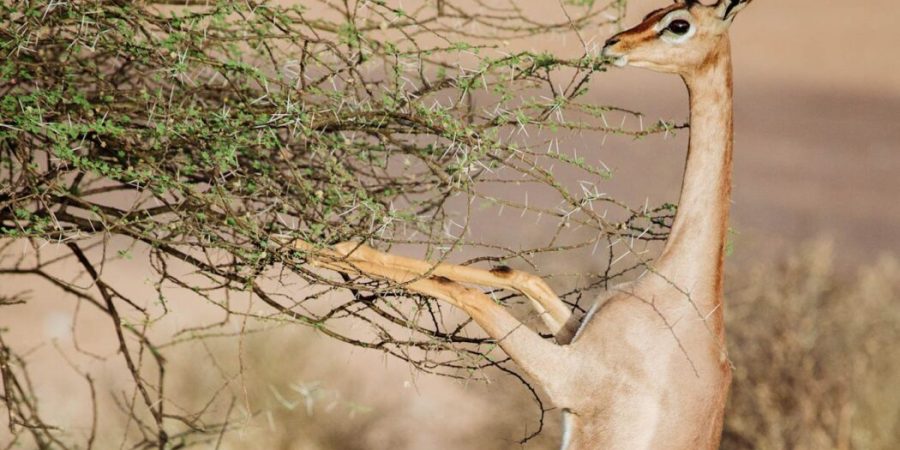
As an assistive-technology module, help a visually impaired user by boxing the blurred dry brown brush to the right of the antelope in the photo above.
[722,243,900,450]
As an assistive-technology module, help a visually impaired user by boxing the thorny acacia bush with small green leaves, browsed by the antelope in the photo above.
[0,0,685,448]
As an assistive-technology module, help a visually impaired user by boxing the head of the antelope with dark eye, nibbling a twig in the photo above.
[603,0,752,75]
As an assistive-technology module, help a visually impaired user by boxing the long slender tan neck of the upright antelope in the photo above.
[656,37,734,309]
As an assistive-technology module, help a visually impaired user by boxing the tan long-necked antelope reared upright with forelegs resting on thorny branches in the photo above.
[294,0,749,450]
